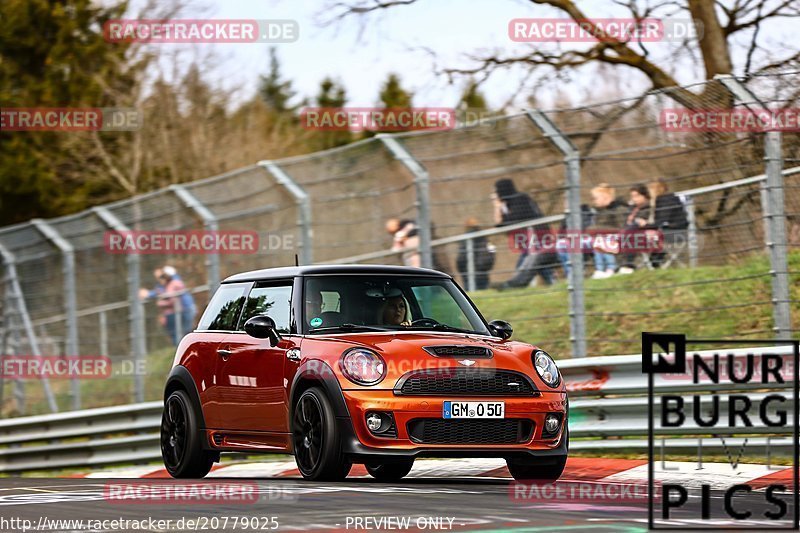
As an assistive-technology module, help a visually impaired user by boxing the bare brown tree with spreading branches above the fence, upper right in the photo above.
[327,0,800,108]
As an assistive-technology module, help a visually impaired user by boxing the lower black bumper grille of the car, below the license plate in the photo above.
[406,418,533,444]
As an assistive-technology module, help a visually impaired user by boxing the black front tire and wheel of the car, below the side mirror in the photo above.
[292,387,353,481]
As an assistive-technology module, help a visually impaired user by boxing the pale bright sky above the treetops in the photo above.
[125,0,785,111]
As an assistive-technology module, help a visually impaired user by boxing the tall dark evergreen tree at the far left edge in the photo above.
[0,0,136,225]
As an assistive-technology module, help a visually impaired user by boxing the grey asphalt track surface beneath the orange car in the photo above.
[0,477,793,533]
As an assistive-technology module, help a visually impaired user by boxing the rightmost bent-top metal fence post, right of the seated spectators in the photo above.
[716,75,792,340]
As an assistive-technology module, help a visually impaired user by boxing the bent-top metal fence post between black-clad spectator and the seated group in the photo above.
[527,110,586,357]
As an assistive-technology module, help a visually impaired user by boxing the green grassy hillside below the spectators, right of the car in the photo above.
[470,250,800,358]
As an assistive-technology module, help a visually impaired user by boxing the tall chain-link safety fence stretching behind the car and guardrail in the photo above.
[0,72,800,415]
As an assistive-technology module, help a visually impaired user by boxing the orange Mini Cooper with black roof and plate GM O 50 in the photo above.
[161,265,569,480]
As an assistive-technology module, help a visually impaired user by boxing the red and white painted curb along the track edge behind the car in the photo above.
[75,457,792,488]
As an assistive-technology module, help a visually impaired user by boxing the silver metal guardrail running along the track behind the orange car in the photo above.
[0,346,794,472]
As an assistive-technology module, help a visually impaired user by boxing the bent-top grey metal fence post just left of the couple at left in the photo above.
[92,207,147,402]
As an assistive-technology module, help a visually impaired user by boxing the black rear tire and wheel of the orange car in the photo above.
[161,390,216,479]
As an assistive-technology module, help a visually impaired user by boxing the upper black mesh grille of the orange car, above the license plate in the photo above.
[394,368,538,396]
